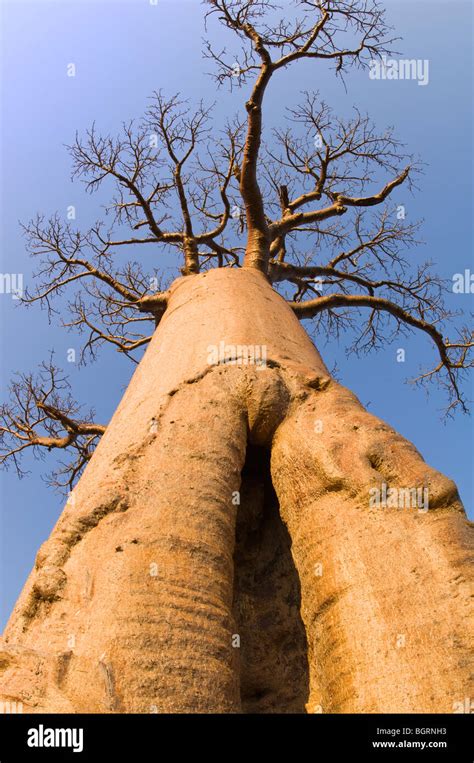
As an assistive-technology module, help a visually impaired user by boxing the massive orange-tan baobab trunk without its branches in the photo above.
[0,269,473,713]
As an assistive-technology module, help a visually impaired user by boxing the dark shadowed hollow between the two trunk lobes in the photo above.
[233,444,309,713]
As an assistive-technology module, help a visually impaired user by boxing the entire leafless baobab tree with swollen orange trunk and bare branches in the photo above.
[0,0,472,713]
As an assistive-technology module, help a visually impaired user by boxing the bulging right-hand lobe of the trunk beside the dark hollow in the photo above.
[272,384,473,713]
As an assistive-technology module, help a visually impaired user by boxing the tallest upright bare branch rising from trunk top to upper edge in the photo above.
[206,0,400,272]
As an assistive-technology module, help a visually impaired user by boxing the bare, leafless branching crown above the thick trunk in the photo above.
[0,0,473,487]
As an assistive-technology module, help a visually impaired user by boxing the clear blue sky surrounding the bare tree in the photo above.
[0,0,474,629]
